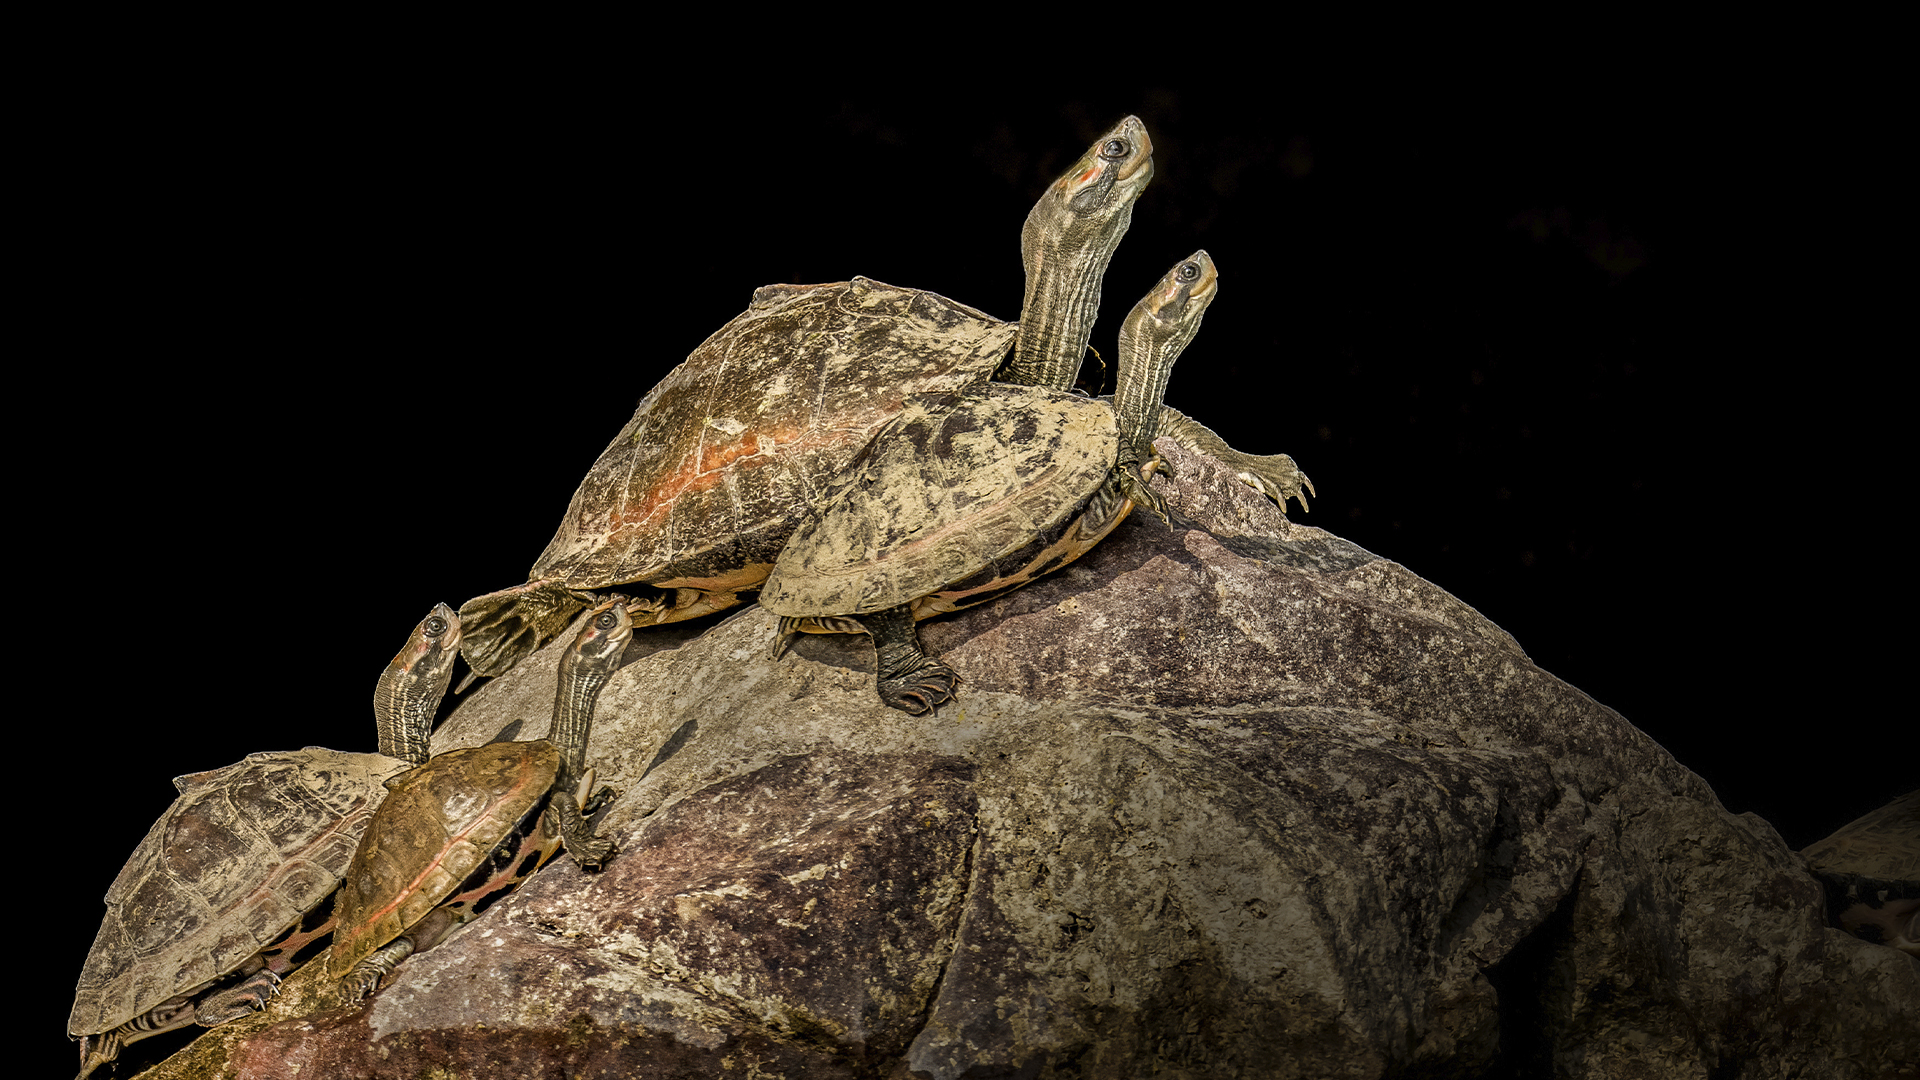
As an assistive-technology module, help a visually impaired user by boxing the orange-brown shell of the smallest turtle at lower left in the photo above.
[328,740,561,978]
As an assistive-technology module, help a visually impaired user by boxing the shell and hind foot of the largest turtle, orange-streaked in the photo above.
[461,277,1016,675]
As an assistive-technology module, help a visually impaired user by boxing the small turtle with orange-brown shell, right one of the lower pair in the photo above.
[328,596,634,1001]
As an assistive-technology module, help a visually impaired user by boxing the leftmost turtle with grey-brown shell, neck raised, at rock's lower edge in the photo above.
[67,603,461,1078]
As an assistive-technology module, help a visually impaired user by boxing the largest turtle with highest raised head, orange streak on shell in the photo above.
[461,115,1311,675]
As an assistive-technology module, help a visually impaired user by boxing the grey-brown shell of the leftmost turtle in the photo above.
[67,746,407,1038]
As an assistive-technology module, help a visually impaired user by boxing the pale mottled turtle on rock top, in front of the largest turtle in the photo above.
[760,250,1217,715]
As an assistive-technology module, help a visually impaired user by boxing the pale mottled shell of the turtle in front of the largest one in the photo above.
[760,384,1119,617]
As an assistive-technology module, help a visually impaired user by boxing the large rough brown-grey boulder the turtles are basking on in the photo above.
[139,444,1920,1080]
